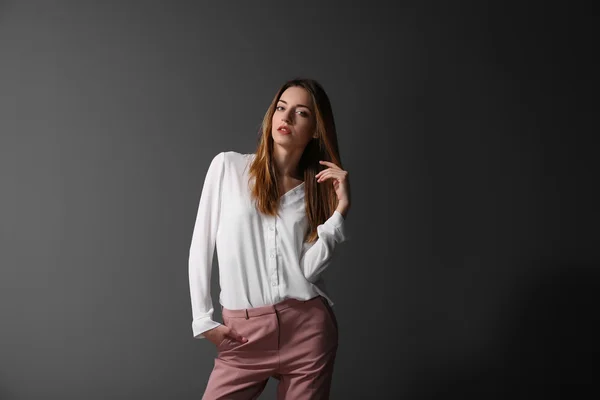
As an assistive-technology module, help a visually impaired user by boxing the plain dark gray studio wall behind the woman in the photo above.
[0,1,599,400]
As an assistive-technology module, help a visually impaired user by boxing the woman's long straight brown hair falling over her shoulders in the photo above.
[248,78,344,242]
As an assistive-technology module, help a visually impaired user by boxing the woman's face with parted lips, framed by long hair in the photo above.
[271,86,316,149]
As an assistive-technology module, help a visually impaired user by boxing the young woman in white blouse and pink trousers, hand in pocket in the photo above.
[189,79,350,400]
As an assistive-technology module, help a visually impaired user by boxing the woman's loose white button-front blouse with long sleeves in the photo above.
[189,151,349,339]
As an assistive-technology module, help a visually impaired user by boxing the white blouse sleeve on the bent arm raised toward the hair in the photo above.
[300,210,350,283]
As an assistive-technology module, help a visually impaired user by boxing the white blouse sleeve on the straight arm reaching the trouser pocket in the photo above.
[189,152,225,339]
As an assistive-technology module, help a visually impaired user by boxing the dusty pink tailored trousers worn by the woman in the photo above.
[202,296,338,400]
